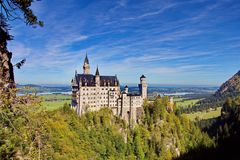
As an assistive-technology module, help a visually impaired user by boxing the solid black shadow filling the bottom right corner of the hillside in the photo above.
[175,134,240,160]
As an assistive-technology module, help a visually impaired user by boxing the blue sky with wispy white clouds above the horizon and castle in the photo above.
[8,0,240,85]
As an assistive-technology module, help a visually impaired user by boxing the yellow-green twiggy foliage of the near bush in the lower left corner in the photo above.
[0,91,49,160]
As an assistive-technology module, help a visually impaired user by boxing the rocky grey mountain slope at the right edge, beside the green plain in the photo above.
[194,71,240,110]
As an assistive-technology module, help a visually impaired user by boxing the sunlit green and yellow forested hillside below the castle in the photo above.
[0,93,213,160]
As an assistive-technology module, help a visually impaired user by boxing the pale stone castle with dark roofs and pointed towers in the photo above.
[71,55,147,124]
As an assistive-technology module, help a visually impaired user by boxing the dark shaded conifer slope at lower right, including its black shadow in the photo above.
[175,97,240,160]
